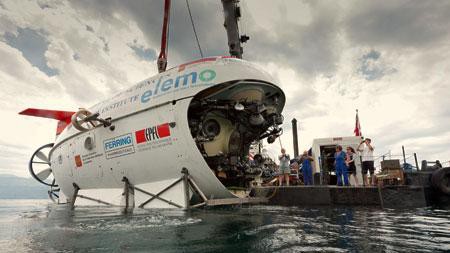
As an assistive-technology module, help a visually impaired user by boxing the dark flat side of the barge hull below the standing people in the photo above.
[251,185,450,208]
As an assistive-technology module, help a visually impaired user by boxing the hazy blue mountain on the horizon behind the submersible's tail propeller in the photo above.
[0,174,49,199]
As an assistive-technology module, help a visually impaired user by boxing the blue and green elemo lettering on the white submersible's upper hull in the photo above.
[141,69,216,103]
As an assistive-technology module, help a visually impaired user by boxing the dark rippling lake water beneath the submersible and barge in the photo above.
[0,200,450,252]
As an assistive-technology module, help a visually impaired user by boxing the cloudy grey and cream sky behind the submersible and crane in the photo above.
[0,0,450,177]
